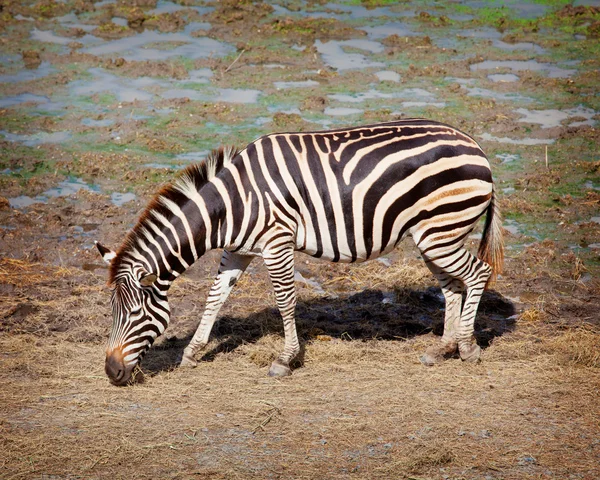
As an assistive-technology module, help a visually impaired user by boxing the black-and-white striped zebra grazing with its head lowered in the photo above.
[97,119,503,385]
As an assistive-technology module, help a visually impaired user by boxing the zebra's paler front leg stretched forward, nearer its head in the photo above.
[180,250,254,367]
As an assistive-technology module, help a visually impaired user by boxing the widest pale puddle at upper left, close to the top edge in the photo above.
[82,29,235,61]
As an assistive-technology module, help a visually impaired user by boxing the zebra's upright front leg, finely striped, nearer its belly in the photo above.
[263,243,300,377]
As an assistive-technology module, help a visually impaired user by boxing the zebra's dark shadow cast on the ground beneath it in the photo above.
[143,287,516,376]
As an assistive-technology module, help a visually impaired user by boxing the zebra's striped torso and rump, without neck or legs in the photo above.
[241,119,493,261]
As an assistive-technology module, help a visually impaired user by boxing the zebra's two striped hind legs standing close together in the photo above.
[423,248,492,364]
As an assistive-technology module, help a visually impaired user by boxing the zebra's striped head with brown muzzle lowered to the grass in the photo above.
[96,242,169,386]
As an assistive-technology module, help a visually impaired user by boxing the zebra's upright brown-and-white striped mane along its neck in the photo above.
[108,146,239,285]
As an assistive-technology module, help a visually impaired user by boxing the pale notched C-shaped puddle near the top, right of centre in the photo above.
[315,39,385,70]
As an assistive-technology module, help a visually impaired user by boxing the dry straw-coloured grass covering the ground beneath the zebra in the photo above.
[0,246,600,480]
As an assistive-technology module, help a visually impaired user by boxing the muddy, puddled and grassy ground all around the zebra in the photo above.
[0,0,600,480]
